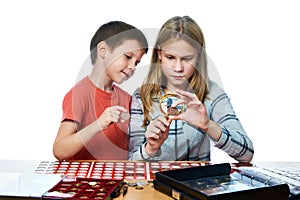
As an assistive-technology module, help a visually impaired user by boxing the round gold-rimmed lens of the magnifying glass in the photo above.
[159,94,185,118]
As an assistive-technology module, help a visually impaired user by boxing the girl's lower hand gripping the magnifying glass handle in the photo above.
[145,116,171,157]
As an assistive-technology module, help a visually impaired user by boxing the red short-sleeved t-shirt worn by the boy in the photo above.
[62,77,131,160]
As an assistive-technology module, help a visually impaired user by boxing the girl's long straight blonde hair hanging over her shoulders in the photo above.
[140,16,208,126]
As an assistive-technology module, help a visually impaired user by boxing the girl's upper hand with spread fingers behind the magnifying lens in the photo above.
[169,89,209,131]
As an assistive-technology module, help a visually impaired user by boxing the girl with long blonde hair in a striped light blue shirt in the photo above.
[129,16,254,162]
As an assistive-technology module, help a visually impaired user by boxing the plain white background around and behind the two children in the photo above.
[0,0,300,162]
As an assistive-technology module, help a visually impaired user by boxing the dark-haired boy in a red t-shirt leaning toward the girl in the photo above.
[53,21,148,160]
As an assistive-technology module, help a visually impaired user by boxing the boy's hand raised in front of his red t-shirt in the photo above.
[97,106,130,130]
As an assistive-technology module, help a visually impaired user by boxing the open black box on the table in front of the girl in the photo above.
[153,163,290,200]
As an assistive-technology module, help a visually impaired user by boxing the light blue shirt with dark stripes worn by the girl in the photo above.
[129,81,254,162]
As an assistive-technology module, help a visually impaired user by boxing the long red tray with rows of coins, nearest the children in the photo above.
[34,161,208,181]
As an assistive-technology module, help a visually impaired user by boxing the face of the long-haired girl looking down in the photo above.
[157,40,198,91]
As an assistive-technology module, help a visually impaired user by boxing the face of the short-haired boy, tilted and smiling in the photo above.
[105,40,145,84]
